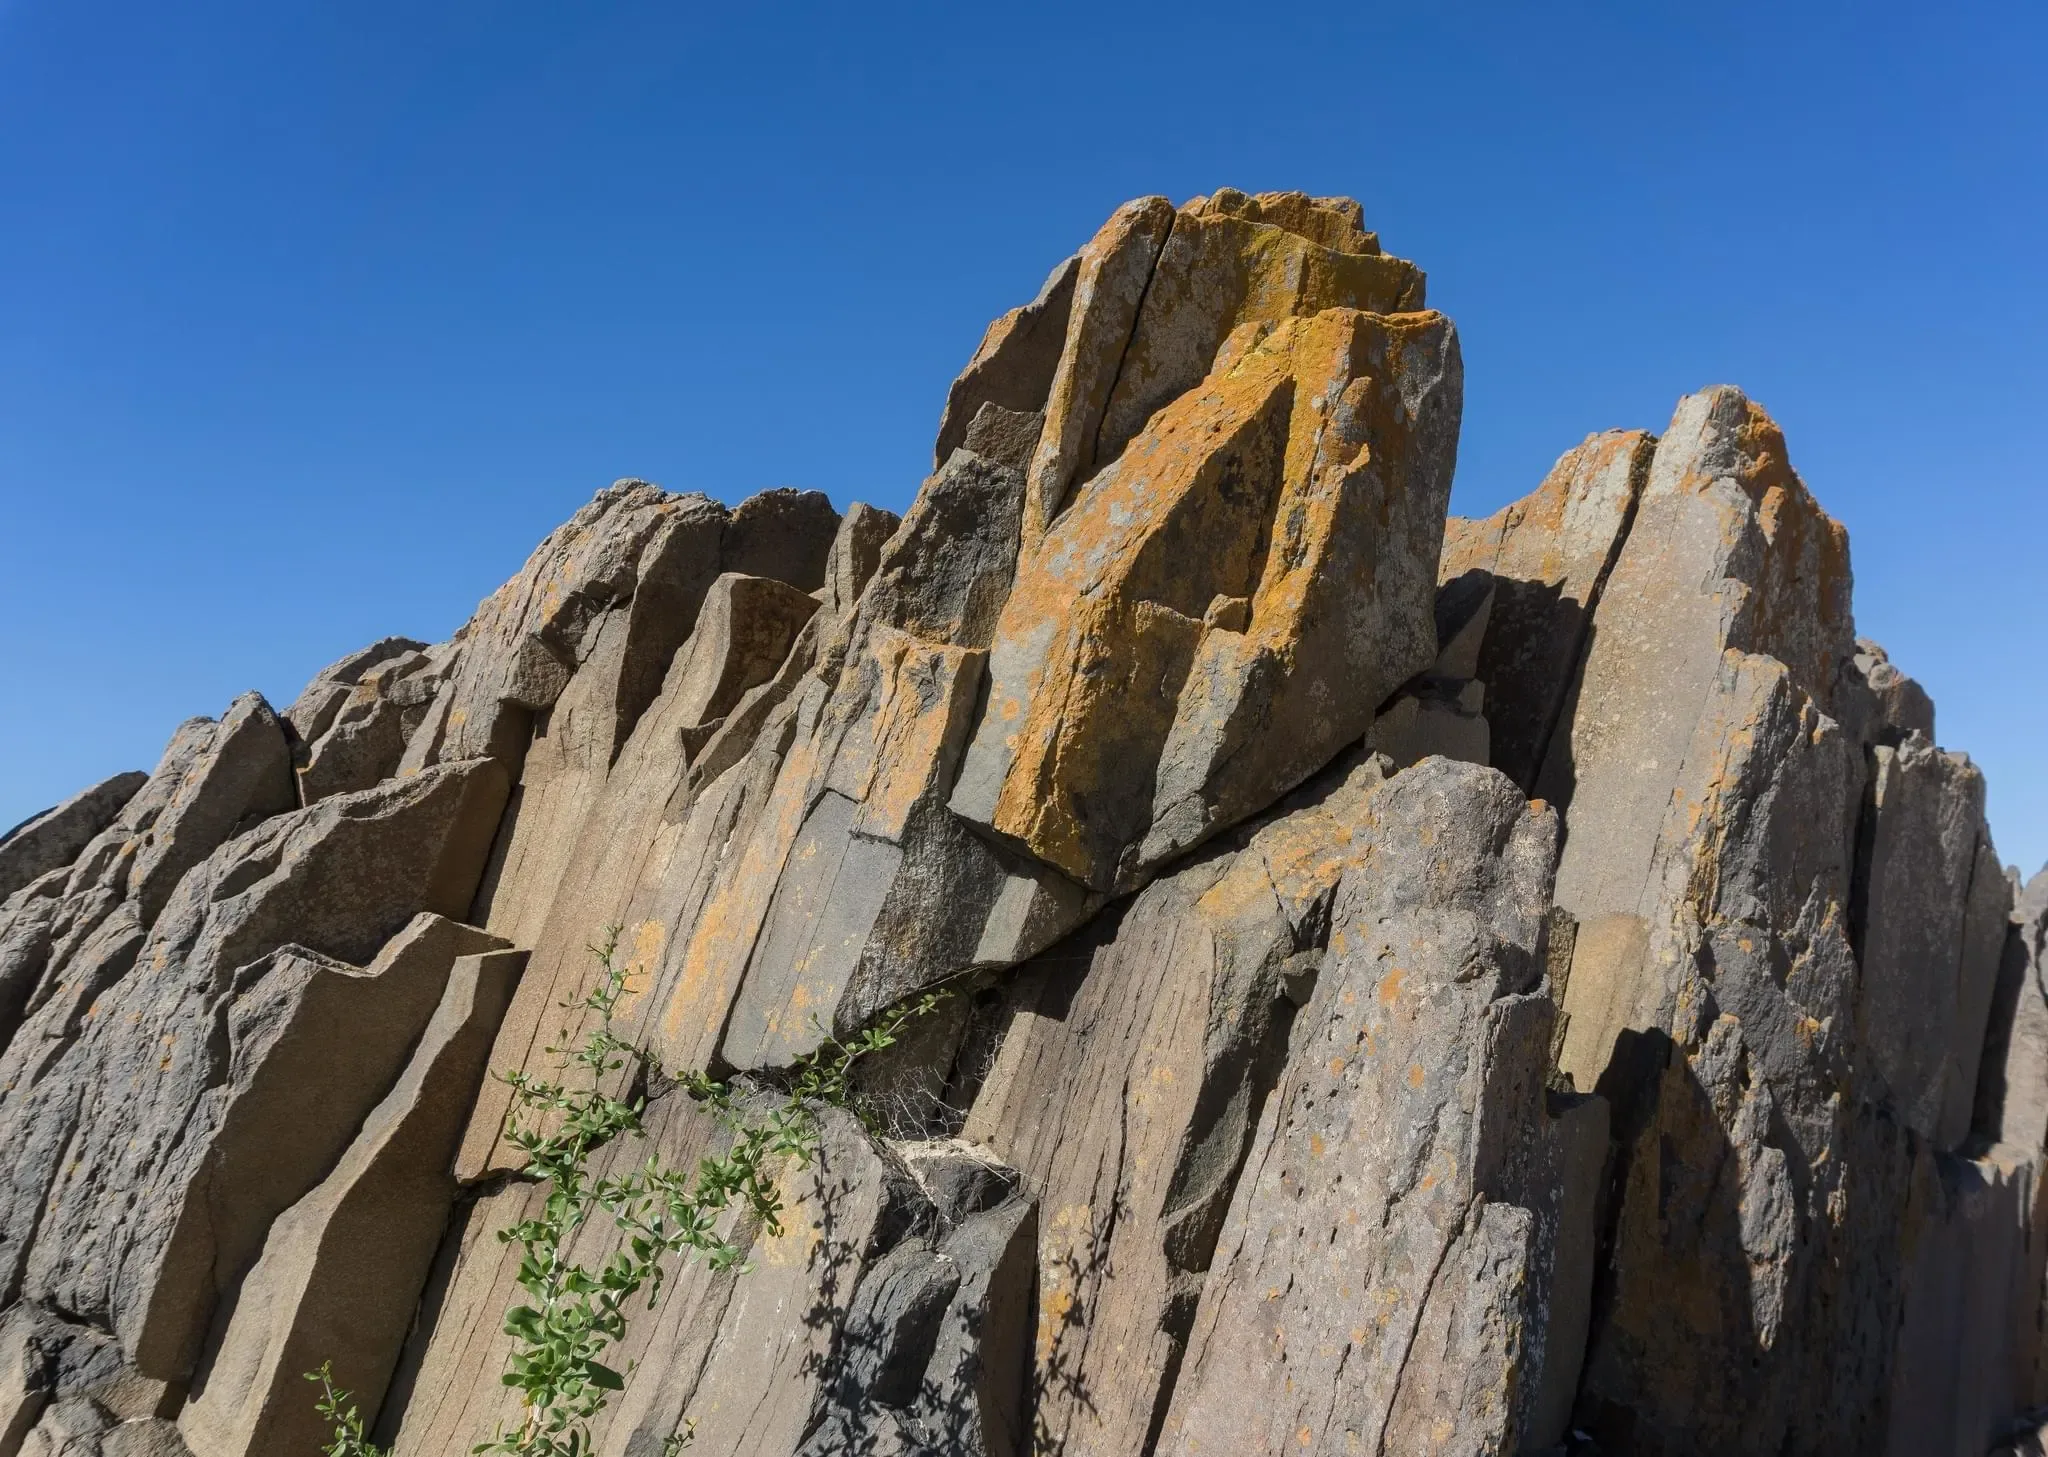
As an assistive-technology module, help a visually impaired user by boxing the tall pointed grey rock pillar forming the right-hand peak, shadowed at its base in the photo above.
[1538,389,1884,1453]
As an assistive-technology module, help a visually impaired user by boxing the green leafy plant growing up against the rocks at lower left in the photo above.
[307,926,946,1457]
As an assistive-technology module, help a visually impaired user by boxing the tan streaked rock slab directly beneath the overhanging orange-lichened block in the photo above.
[965,760,1384,1457]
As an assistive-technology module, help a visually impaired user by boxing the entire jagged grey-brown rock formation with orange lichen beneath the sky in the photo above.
[0,191,2048,1457]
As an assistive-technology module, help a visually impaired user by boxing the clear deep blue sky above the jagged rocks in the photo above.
[0,0,2048,869]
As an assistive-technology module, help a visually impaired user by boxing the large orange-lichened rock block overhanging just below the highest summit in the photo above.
[950,309,1460,891]
